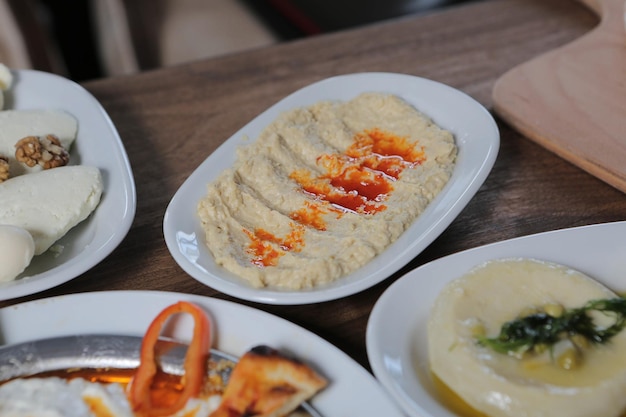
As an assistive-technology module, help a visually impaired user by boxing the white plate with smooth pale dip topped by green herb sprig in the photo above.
[366,222,626,417]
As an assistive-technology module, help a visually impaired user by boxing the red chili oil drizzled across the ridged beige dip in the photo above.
[244,128,426,267]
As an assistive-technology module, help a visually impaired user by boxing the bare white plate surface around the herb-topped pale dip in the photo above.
[366,222,626,417]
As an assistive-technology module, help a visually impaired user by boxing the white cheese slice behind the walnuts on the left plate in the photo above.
[0,109,78,177]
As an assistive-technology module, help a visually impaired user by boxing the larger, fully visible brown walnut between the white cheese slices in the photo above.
[15,134,70,169]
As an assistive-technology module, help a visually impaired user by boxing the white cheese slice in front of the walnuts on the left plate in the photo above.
[0,165,103,255]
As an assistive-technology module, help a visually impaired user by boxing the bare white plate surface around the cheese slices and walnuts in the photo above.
[0,70,136,300]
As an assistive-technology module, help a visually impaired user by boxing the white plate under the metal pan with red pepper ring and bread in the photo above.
[0,291,403,417]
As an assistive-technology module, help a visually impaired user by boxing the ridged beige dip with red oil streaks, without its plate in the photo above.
[198,93,457,289]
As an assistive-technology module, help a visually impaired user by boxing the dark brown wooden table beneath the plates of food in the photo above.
[0,0,626,369]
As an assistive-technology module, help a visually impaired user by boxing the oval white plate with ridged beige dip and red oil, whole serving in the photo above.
[164,73,499,304]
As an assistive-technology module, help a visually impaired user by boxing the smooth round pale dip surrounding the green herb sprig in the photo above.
[428,259,626,417]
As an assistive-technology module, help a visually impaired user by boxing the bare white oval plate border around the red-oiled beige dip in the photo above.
[163,73,500,304]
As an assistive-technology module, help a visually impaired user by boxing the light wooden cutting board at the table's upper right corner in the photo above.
[493,0,626,192]
